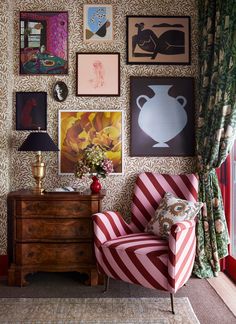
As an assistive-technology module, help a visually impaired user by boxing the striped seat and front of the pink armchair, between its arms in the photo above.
[101,233,169,290]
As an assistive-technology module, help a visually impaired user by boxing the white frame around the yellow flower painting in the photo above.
[58,109,124,176]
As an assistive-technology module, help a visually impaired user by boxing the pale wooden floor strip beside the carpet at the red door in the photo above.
[207,272,236,316]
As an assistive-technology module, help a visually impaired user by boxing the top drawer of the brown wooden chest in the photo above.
[16,200,92,217]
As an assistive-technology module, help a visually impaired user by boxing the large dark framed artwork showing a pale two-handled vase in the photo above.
[130,77,195,156]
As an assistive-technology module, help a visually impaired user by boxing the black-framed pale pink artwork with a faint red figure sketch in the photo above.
[76,53,120,96]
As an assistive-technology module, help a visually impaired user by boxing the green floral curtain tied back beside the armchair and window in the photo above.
[194,0,236,278]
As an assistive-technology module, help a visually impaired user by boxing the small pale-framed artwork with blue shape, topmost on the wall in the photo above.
[83,4,113,42]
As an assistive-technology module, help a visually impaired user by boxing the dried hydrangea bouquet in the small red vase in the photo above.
[75,145,113,179]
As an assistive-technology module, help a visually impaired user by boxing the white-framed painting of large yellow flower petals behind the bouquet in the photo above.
[58,110,123,175]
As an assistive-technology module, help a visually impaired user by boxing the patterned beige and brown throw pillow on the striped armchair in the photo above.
[145,192,203,239]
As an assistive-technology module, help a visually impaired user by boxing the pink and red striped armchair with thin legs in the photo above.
[92,172,198,314]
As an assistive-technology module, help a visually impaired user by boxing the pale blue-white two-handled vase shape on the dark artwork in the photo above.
[136,85,188,147]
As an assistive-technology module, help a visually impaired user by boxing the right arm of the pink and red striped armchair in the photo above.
[168,220,196,293]
